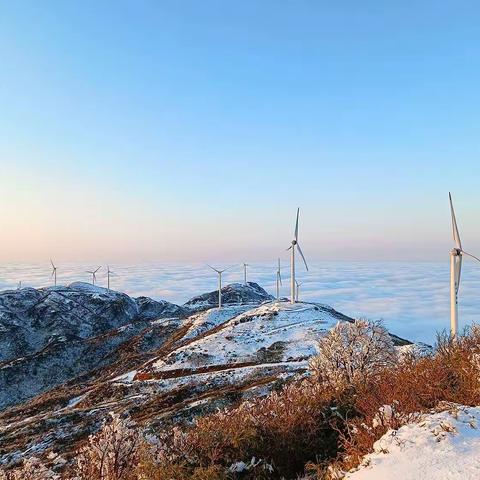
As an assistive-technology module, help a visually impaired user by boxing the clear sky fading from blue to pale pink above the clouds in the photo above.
[0,0,480,261]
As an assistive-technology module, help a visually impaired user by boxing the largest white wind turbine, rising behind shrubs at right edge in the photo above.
[448,193,480,338]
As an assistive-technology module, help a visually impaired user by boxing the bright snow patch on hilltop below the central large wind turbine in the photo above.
[153,302,338,371]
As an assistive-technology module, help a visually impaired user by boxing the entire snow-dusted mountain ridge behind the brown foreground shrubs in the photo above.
[0,283,409,465]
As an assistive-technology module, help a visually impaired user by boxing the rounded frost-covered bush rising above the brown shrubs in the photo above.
[310,320,397,388]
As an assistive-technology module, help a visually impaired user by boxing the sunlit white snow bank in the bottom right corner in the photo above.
[346,404,480,480]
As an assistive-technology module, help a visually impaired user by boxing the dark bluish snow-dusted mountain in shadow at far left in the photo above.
[0,282,184,409]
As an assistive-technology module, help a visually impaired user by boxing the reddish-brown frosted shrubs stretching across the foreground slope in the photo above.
[0,325,480,480]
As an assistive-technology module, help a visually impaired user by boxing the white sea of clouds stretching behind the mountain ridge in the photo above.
[0,260,480,343]
